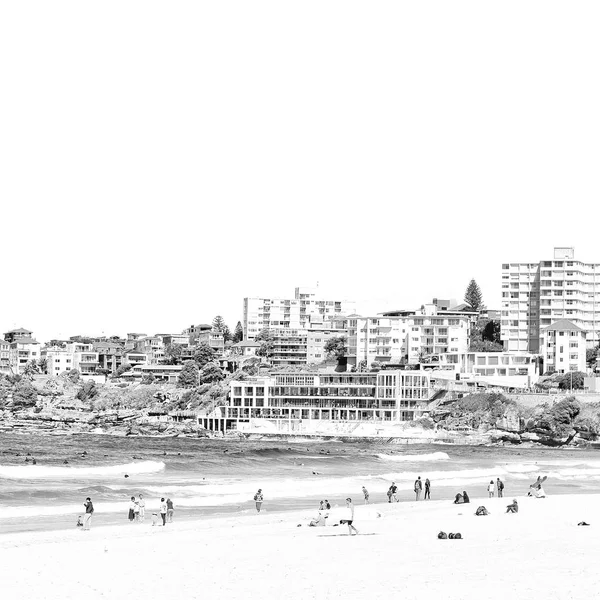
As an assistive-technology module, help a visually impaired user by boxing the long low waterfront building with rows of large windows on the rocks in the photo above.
[216,370,435,433]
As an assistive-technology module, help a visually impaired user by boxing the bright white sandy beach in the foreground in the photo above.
[0,490,600,600]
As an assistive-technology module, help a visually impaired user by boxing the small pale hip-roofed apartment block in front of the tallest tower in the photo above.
[541,319,586,373]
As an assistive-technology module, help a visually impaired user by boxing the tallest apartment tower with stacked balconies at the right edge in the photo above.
[500,248,600,354]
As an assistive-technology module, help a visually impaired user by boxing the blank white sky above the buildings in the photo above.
[0,0,600,341]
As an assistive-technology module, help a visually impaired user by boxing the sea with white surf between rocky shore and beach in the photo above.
[0,433,600,533]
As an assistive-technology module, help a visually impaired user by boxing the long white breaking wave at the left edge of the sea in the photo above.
[0,460,165,479]
